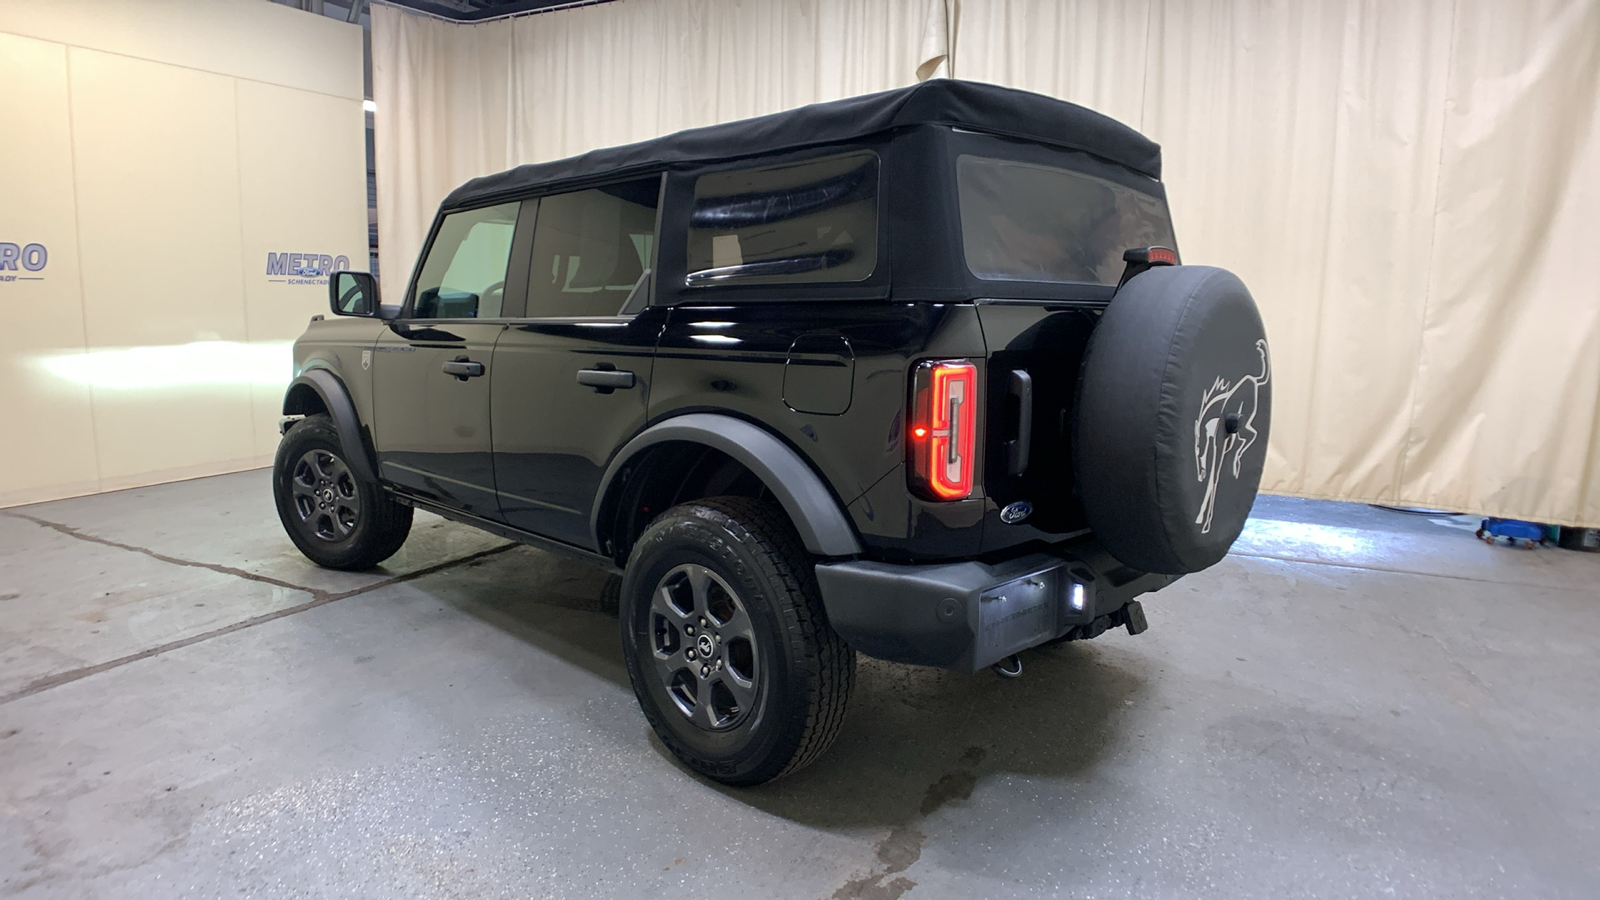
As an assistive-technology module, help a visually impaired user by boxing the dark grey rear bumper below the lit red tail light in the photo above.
[816,540,1179,673]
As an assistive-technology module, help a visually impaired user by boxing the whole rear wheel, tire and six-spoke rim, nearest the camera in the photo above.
[619,496,856,785]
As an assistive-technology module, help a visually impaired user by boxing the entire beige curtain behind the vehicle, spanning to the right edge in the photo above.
[373,0,1600,525]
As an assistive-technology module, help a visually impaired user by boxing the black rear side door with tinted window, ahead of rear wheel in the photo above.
[490,176,666,548]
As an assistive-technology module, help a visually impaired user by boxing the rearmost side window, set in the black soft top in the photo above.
[688,151,878,287]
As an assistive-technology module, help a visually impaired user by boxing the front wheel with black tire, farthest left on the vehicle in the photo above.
[272,415,411,570]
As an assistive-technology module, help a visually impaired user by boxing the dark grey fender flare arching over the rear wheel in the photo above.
[589,413,861,556]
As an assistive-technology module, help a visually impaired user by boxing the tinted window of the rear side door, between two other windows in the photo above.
[528,176,661,317]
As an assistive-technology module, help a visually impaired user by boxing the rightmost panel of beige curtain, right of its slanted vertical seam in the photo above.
[1400,0,1600,525]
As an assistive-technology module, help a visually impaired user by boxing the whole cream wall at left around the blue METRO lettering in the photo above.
[0,0,366,504]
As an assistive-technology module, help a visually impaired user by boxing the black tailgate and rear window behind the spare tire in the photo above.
[952,135,1176,551]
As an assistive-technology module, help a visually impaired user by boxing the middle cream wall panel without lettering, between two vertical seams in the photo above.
[67,48,254,479]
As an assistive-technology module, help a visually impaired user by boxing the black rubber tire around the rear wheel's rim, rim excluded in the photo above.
[619,496,856,785]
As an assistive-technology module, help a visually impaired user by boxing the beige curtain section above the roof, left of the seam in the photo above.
[373,0,949,296]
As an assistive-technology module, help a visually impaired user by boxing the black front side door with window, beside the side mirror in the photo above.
[371,203,520,519]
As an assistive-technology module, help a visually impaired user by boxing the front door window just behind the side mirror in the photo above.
[411,203,522,319]
